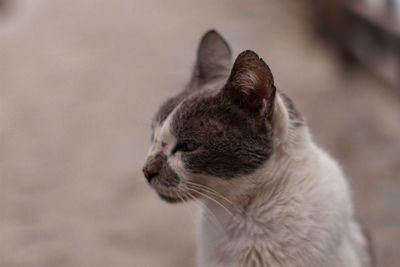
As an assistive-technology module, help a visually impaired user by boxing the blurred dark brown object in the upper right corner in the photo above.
[312,0,400,88]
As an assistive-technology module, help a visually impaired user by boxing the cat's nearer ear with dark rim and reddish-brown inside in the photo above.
[222,50,276,118]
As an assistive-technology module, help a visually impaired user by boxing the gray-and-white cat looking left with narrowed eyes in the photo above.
[143,30,371,267]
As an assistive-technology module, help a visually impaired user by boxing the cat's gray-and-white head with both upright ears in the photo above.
[143,31,302,202]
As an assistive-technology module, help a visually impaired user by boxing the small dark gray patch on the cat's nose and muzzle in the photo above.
[143,153,180,187]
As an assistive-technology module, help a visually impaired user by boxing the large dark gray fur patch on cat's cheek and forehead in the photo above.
[171,94,272,179]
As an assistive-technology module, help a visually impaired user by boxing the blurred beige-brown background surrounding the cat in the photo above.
[0,0,400,267]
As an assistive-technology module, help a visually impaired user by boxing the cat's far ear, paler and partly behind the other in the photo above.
[193,30,232,83]
